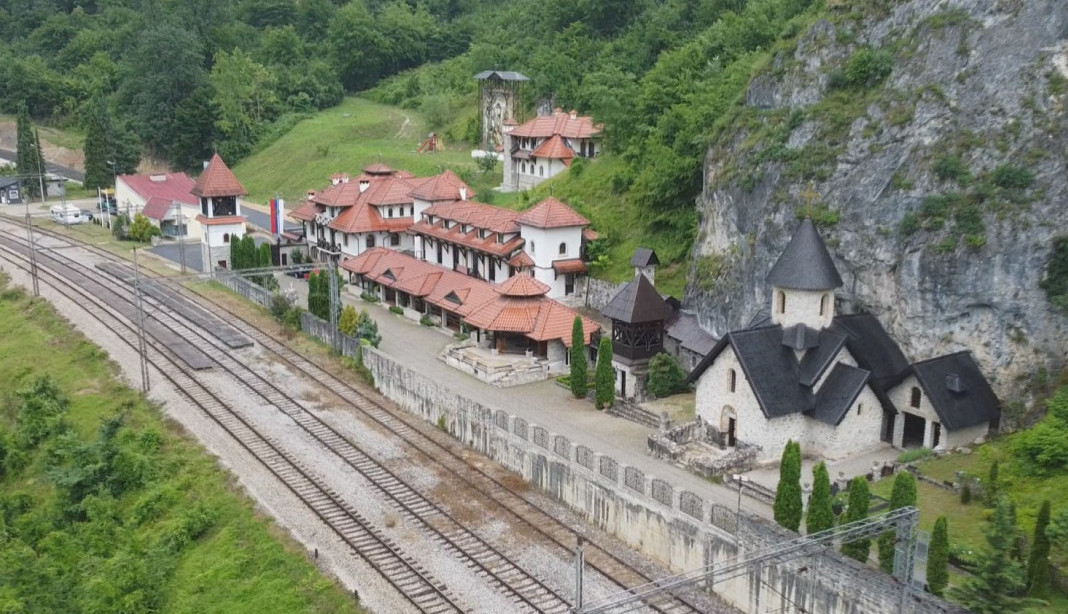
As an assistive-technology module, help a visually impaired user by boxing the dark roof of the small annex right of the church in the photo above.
[912,351,1001,430]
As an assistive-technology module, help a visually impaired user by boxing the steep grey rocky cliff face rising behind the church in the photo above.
[686,0,1068,398]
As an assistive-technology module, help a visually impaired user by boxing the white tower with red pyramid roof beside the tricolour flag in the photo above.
[189,154,249,271]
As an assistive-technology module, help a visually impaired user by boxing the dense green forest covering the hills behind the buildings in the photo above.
[0,0,815,289]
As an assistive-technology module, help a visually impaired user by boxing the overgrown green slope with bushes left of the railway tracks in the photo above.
[0,278,358,614]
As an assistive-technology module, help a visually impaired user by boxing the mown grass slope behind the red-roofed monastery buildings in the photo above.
[233,97,491,206]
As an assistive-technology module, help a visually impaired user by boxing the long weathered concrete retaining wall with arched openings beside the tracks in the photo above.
[356,341,962,614]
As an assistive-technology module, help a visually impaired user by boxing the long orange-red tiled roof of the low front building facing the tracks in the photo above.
[341,248,600,345]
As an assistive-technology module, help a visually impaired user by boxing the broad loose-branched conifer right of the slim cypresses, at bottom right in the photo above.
[949,500,1027,614]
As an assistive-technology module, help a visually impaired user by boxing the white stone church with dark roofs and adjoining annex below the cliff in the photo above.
[689,220,1001,461]
